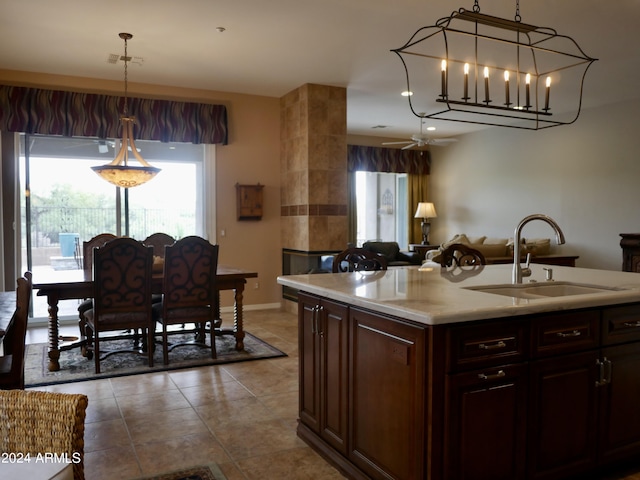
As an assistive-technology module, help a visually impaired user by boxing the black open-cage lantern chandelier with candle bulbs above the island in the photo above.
[391,0,596,130]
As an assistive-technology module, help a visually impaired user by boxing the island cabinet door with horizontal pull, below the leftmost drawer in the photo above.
[445,364,528,480]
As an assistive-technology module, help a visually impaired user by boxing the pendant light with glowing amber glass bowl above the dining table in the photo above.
[91,33,160,188]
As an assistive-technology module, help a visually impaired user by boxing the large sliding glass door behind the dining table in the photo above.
[20,135,205,316]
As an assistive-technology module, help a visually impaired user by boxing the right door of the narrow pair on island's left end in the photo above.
[318,299,349,453]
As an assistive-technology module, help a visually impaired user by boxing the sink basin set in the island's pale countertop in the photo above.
[466,282,623,300]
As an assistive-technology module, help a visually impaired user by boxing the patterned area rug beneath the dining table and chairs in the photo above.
[24,332,286,387]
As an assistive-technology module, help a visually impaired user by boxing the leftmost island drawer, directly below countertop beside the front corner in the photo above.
[447,320,528,371]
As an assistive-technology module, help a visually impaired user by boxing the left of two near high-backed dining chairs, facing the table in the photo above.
[84,237,155,373]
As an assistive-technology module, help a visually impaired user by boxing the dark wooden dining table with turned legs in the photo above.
[33,265,258,372]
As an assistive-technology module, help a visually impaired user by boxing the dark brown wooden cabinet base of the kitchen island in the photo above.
[298,294,640,480]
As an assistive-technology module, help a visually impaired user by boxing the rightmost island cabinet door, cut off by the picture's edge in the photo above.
[600,343,640,463]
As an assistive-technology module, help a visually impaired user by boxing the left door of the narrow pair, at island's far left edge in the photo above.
[298,292,320,433]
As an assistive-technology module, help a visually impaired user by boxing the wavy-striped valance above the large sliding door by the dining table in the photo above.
[0,85,228,145]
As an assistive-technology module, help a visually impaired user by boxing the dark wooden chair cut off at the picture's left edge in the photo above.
[0,272,32,390]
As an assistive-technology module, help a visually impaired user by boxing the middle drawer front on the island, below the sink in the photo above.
[531,311,600,357]
